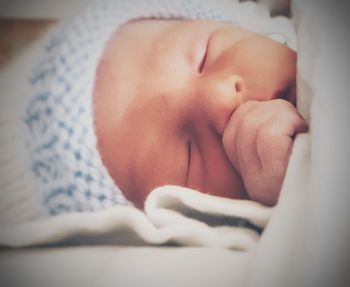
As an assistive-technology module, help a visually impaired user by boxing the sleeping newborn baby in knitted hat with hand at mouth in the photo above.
[23,0,307,214]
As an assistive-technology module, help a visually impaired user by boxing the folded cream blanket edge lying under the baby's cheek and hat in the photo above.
[0,186,271,250]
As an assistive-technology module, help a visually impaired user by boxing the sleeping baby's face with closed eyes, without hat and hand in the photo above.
[94,20,296,207]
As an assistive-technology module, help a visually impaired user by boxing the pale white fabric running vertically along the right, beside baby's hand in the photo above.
[248,0,350,287]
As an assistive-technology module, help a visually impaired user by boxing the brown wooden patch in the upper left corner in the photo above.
[0,19,55,67]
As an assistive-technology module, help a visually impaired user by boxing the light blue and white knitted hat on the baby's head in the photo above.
[23,0,296,215]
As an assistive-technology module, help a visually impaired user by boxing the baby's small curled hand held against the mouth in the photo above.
[223,99,307,205]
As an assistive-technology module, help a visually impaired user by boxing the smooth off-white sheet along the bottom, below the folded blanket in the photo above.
[0,246,251,287]
